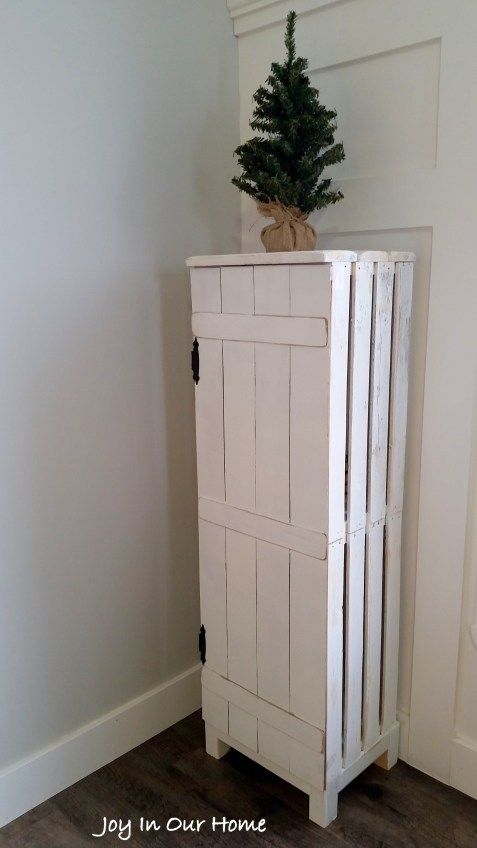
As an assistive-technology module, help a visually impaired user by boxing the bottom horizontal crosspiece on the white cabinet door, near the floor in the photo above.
[202,665,324,753]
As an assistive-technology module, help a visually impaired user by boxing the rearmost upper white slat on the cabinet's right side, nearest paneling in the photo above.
[387,263,413,514]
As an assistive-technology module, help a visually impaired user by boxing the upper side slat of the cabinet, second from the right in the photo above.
[368,262,394,523]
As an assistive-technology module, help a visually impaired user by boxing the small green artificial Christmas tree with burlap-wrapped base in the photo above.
[232,12,344,251]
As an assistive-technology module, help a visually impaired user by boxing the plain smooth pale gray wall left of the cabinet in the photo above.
[0,0,239,767]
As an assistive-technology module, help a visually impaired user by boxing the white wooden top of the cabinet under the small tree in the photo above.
[186,250,416,268]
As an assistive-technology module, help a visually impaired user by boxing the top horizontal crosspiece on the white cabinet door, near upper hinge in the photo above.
[192,312,328,347]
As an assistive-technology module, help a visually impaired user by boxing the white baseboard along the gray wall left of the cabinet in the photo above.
[0,666,201,827]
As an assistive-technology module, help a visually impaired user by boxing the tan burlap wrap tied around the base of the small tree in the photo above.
[257,200,316,253]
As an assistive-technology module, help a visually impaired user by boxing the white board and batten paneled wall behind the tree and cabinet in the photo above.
[236,0,477,791]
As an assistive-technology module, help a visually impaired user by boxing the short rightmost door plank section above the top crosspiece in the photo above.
[290,265,331,320]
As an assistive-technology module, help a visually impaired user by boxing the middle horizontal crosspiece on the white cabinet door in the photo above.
[199,498,327,560]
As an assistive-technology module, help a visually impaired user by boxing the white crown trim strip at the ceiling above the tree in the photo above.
[227,0,343,35]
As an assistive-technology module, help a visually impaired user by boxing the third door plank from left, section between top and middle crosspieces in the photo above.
[255,344,290,522]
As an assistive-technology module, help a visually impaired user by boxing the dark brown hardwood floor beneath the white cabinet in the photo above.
[0,713,477,848]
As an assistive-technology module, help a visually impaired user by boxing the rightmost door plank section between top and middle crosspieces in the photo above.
[290,342,329,533]
